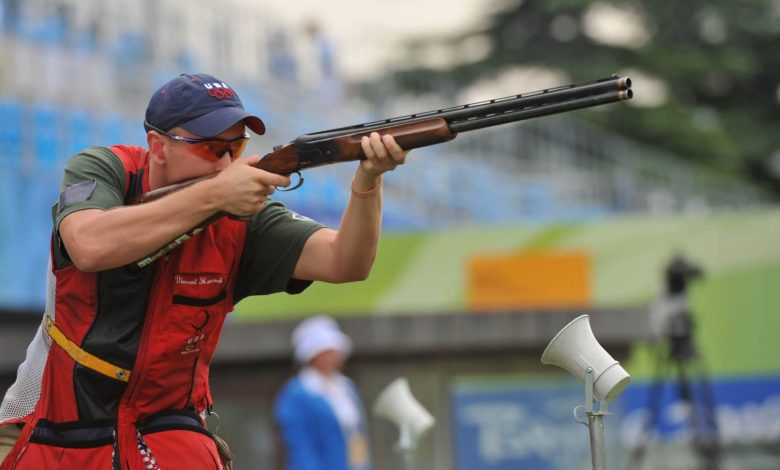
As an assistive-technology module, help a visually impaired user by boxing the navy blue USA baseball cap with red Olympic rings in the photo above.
[144,73,265,137]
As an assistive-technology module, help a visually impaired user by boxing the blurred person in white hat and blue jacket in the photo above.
[274,316,371,470]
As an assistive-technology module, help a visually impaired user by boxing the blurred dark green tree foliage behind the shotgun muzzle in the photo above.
[384,0,780,194]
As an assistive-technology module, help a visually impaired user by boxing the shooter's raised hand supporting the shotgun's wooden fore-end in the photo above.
[354,132,409,191]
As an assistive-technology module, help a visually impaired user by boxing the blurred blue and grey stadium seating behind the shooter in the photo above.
[0,0,764,312]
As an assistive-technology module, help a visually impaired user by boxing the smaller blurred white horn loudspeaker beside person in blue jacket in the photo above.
[373,377,436,451]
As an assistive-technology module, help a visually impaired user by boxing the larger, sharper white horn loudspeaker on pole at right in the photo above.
[542,315,631,401]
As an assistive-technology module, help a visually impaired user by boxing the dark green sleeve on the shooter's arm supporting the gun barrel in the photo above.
[233,201,324,303]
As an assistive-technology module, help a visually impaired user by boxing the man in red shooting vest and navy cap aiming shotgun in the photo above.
[0,74,406,470]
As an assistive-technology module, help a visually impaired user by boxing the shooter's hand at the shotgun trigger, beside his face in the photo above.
[213,155,290,216]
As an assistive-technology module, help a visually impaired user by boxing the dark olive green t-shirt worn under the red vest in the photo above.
[52,147,323,302]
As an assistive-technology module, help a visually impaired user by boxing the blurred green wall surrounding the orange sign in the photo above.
[235,210,780,376]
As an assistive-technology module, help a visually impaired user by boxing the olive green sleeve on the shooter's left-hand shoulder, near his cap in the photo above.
[52,147,126,230]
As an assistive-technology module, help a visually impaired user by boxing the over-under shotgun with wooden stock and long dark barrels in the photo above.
[129,75,633,267]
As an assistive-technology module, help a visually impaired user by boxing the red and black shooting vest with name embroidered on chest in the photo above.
[0,146,241,470]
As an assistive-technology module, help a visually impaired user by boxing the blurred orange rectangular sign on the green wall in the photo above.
[468,251,591,310]
